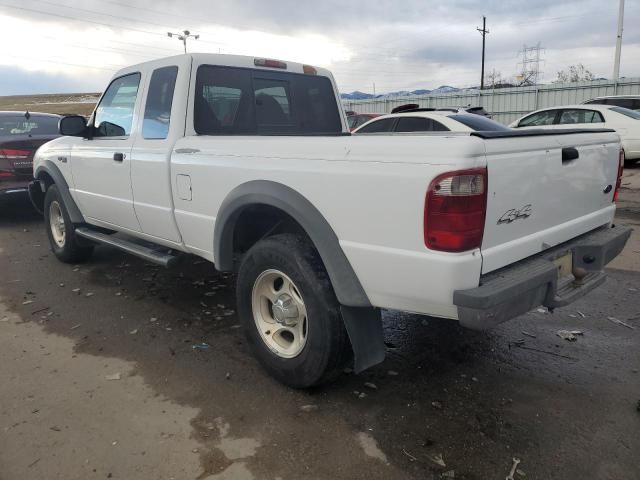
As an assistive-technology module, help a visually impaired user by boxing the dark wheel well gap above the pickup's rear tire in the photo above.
[233,205,308,257]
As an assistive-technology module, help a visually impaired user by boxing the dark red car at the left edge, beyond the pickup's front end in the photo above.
[0,112,62,198]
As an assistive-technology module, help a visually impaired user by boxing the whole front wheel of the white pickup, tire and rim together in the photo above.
[44,185,93,263]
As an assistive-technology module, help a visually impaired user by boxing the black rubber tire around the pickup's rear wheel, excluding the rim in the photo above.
[236,234,352,388]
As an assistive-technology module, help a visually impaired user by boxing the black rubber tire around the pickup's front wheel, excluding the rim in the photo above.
[44,185,93,263]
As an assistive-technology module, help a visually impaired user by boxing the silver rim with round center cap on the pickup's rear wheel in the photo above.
[251,269,309,358]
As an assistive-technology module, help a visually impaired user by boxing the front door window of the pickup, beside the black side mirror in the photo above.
[93,73,140,137]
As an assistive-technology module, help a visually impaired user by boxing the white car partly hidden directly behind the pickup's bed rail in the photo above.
[353,108,510,135]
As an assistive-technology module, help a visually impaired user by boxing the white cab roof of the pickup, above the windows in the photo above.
[115,53,333,78]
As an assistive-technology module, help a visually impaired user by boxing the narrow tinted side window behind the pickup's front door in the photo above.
[142,66,178,139]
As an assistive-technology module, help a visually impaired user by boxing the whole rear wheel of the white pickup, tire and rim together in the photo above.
[237,234,351,388]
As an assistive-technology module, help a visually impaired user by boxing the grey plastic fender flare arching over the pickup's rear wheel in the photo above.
[213,180,371,307]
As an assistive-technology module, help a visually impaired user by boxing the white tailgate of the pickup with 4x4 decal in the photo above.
[482,131,620,274]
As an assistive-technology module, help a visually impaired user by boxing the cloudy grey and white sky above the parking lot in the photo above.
[0,0,640,95]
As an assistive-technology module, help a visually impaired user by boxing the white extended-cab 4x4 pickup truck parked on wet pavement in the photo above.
[30,54,630,387]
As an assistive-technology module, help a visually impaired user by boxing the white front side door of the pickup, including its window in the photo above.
[71,72,141,232]
